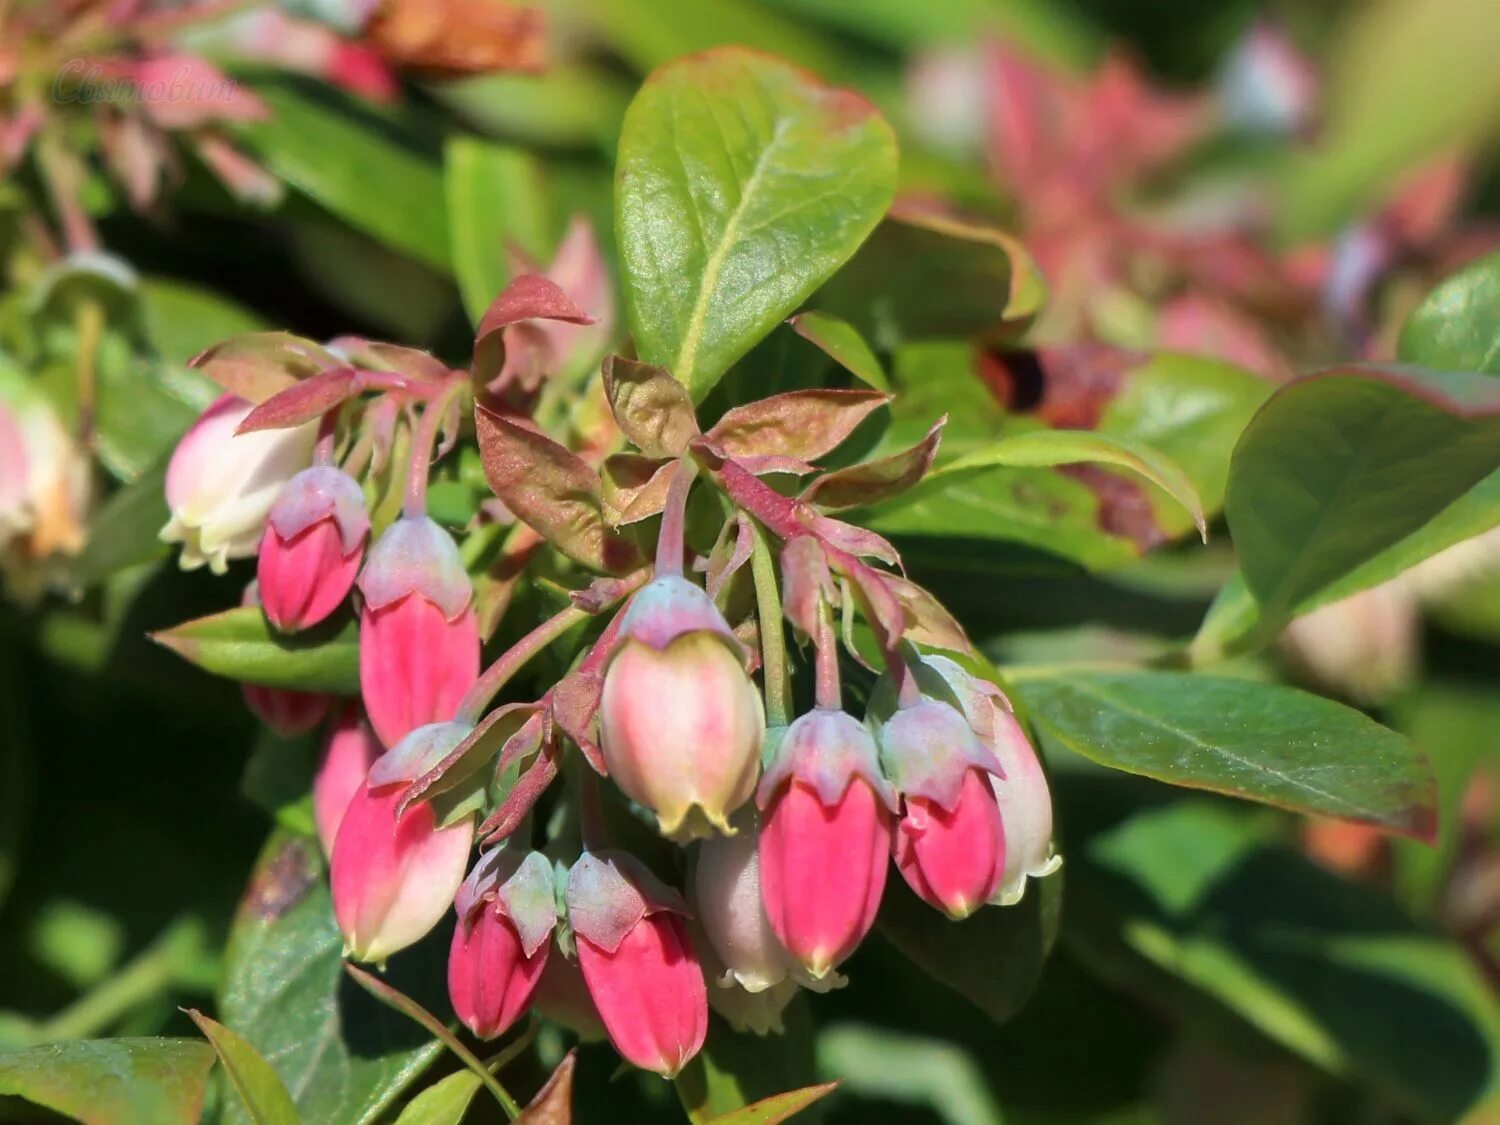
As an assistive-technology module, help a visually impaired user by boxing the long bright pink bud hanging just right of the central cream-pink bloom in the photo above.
[756,710,896,980]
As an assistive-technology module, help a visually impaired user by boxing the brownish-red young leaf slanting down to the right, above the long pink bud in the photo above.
[474,407,641,573]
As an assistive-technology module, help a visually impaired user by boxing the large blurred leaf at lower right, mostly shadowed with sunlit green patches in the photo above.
[1067,800,1500,1122]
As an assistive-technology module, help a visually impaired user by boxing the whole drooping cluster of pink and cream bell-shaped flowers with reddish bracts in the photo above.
[164,253,1059,1076]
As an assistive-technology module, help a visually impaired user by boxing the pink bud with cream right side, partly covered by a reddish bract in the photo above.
[330,723,474,962]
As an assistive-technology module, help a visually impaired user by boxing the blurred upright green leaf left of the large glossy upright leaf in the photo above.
[444,137,564,324]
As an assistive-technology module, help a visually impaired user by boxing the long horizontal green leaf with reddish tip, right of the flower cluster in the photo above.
[1008,669,1437,840]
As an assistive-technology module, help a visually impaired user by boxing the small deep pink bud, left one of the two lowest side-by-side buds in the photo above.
[449,848,557,1040]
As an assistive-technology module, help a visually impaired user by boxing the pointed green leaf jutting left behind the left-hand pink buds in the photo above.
[152,606,360,695]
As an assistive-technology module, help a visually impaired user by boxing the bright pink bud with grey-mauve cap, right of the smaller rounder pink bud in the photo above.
[359,516,479,746]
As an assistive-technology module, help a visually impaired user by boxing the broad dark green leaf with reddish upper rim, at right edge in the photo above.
[1226,368,1500,623]
